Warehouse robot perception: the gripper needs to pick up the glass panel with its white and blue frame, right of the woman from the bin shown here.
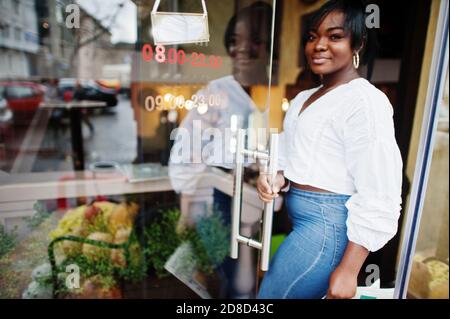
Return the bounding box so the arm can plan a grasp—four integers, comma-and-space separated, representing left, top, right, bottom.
396, 1, 449, 299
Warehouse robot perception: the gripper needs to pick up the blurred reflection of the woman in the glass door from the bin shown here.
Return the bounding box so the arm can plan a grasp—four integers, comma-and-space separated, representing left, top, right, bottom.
169, 2, 272, 297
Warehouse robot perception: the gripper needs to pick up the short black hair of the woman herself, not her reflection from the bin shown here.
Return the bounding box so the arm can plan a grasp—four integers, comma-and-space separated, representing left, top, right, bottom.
303, 0, 378, 78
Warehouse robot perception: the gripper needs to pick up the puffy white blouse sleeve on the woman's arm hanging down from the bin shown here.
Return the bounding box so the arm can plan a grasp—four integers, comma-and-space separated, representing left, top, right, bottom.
343, 98, 403, 251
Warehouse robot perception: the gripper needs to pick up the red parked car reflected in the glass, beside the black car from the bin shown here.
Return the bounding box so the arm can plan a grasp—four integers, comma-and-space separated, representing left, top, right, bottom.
0, 81, 45, 112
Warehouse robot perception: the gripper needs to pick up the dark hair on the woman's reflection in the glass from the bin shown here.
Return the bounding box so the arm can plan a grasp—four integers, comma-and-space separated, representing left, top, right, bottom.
224, 1, 273, 53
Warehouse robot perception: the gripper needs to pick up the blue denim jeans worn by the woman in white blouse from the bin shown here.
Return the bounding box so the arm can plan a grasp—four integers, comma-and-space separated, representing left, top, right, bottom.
258, 187, 350, 299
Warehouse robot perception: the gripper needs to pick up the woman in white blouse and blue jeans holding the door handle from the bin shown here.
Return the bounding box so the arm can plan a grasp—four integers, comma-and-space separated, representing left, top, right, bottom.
257, 0, 402, 298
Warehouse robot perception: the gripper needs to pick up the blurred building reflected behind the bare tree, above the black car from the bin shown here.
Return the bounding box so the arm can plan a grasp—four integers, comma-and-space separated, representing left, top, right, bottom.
36, 0, 131, 79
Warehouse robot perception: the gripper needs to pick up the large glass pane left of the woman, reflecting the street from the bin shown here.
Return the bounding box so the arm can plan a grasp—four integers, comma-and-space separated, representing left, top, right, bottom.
0, 0, 276, 298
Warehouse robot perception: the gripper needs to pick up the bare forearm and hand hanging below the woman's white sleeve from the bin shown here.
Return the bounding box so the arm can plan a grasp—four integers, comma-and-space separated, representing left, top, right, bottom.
327, 241, 369, 299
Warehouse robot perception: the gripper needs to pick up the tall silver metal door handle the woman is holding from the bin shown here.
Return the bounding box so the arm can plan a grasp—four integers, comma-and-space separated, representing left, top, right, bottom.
230, 129, 278, 271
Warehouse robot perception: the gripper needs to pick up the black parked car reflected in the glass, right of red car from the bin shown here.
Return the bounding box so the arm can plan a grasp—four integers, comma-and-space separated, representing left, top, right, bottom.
58, 79, 117, 106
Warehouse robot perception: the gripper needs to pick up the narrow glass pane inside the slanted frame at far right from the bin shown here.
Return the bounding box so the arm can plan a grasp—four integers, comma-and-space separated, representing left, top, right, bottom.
408, 70, 449, 299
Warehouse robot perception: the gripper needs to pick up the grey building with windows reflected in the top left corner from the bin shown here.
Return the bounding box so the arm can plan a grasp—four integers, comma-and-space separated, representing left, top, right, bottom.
0, 0, 39, 77
